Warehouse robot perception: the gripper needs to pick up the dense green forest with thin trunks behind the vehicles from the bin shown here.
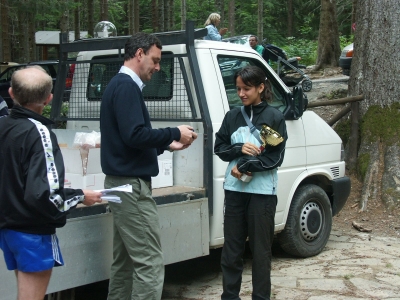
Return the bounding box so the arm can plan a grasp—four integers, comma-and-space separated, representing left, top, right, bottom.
0, 0, 355, 65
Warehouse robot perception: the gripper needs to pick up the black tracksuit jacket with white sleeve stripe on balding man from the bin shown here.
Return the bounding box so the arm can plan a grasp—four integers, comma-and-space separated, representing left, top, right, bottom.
0, 106, 84, 234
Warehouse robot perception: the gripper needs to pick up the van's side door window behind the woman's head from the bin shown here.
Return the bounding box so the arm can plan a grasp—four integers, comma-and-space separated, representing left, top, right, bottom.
217, 55, 287, 112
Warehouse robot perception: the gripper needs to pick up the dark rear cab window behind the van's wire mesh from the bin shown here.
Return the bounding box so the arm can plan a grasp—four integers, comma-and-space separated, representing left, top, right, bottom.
87, 55, 173, 101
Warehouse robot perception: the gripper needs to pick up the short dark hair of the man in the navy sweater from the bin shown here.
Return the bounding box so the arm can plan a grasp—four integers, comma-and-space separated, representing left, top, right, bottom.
124, 32, 162, 61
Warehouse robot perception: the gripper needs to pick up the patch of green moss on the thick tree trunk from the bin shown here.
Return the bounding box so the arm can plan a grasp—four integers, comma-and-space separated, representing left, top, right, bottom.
361, 103, 400, 145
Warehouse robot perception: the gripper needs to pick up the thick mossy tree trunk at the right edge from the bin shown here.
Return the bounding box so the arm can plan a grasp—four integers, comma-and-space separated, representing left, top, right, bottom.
349, 0, 400, 210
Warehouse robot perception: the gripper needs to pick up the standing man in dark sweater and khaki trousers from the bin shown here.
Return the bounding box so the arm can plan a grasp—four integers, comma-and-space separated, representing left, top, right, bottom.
100, 33, 197, 300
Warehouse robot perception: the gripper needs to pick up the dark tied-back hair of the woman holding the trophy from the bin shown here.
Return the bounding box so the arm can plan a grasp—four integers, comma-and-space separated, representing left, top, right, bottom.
233, 66, 272, 102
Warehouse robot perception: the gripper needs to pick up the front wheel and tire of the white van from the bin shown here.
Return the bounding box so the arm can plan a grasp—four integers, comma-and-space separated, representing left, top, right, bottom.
278, 184, 332, 257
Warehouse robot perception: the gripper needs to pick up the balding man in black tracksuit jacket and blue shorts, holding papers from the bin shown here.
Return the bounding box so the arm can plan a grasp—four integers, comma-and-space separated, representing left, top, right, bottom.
0, 66, 101, 300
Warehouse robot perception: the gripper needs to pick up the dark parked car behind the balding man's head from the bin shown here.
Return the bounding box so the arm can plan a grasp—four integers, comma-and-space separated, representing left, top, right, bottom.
0, 60, 73, 108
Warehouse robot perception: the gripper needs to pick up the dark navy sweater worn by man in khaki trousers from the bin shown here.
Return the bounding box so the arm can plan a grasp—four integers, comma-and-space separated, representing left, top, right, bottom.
100, 73, 181, 181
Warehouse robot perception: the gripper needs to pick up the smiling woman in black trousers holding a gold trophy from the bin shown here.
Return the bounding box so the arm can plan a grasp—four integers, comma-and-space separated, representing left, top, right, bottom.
214, 66, 287, 299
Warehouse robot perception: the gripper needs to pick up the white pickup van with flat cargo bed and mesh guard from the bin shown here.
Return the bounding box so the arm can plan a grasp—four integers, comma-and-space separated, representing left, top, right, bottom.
0, 22, 350, 298
